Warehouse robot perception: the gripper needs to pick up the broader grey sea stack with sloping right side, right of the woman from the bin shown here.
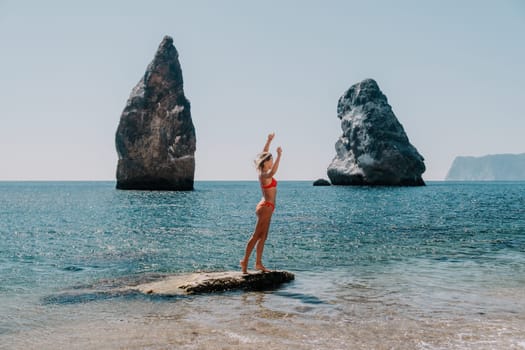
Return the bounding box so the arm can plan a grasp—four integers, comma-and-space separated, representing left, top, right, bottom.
328, 79, 425, 186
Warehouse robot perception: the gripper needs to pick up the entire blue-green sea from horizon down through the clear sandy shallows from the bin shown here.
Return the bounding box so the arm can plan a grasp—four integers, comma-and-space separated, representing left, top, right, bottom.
0, 181, 525, 349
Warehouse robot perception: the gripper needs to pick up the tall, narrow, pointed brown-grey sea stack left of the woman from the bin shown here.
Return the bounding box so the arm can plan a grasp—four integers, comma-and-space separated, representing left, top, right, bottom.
115, 36, 196, 190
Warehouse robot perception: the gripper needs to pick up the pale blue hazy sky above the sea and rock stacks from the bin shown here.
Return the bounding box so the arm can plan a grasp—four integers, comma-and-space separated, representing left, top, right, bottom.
0, 0, 525, 180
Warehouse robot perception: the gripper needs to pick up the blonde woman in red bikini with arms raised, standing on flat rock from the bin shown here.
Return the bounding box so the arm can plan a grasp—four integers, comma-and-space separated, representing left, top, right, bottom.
239, 133, 282, 274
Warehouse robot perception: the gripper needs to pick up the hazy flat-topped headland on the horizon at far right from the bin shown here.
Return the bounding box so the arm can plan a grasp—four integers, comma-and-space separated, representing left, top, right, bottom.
445, 153, 525, 181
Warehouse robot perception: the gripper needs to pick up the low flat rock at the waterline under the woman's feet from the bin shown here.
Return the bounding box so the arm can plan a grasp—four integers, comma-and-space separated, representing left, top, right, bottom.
133, 271, 295, 295
